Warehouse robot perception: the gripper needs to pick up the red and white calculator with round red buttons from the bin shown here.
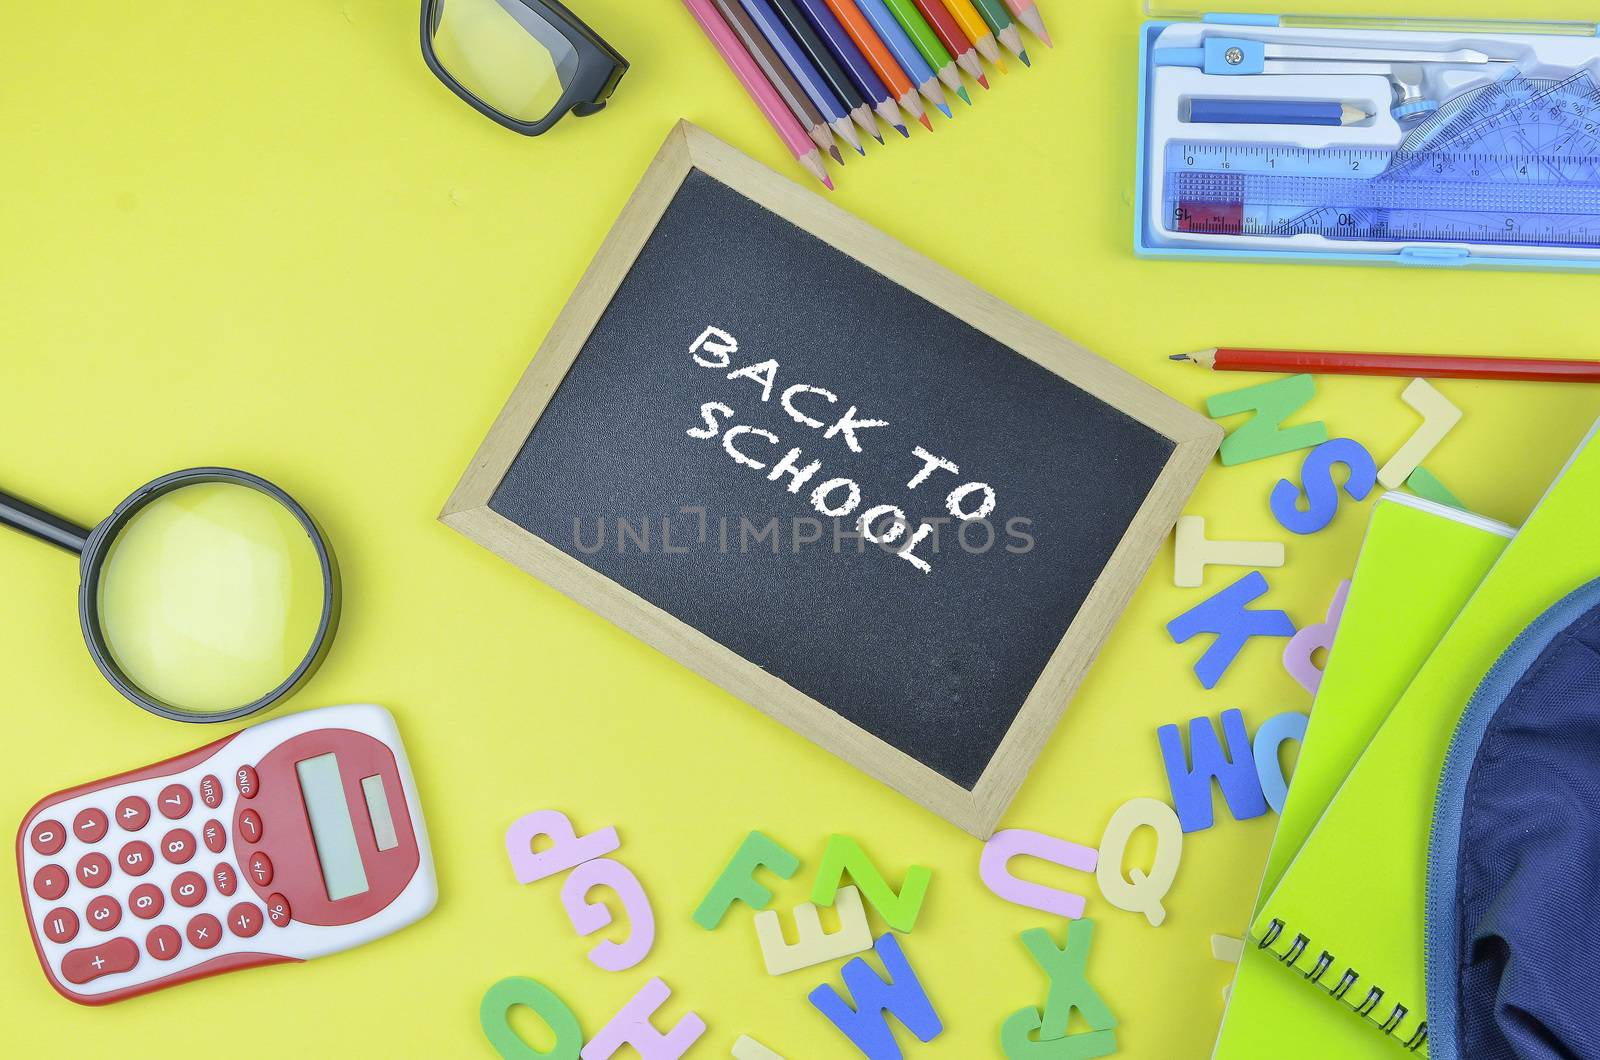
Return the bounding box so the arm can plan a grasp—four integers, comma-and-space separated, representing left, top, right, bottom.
16, 705, 438, 1004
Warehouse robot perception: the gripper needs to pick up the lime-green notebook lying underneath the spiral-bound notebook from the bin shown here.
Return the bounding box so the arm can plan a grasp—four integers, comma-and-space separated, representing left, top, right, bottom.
1213, 493, 1514, 1060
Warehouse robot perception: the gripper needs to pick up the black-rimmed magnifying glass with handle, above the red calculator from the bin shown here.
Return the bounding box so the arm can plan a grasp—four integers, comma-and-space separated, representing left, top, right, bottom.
0, 468, 339, 722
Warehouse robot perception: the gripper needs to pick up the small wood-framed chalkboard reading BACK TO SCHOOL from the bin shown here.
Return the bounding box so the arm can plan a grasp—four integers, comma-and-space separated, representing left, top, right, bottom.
442, 123, 1221, 836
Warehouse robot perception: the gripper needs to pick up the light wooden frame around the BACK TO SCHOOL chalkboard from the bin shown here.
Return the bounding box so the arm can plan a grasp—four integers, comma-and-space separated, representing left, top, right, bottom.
440, 122, 1222, 839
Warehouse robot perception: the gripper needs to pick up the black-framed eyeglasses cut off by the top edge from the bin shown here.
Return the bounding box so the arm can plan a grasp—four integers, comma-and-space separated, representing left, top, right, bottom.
422, 0, 627, 136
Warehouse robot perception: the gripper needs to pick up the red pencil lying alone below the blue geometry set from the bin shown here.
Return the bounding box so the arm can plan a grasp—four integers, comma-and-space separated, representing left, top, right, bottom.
1171, 347, 1600, 383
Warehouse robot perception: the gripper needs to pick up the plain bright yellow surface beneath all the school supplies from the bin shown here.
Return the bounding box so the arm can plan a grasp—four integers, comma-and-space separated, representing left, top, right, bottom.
0, 0, 1600, 1060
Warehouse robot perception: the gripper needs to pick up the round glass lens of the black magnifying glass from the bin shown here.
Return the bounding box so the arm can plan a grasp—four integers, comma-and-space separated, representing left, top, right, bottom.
98, 482, 325, 713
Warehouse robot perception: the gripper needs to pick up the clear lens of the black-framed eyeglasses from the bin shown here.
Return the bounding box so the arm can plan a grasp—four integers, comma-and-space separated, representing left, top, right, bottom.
434, 0, 578, 123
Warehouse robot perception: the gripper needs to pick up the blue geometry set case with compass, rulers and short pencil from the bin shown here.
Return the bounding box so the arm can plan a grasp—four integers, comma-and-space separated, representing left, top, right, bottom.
1134, 6, 1600, 271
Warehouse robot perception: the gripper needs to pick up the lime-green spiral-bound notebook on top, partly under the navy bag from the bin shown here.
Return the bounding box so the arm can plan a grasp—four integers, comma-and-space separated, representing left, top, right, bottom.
1251, 429, 1600, 1054
